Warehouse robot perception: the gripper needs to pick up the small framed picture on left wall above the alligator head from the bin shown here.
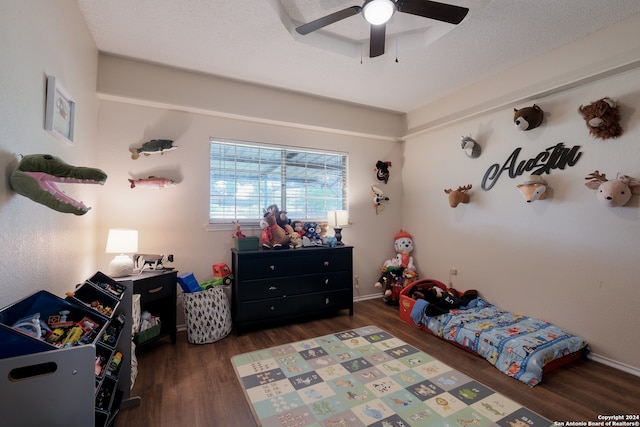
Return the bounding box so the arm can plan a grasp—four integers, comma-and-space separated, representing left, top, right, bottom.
44, 76, 76, 143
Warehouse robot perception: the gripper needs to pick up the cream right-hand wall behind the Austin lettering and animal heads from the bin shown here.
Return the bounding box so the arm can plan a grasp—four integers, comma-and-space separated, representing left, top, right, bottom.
403, 69, 640, 368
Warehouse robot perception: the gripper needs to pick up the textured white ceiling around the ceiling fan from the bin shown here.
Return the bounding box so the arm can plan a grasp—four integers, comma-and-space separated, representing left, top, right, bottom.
76, 0, 640, 112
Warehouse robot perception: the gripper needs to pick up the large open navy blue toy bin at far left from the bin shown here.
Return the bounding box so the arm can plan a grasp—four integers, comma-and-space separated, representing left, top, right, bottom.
0, 290, 107, 359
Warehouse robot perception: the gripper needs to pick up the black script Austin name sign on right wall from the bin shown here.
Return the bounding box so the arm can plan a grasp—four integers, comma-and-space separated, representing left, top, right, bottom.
482, 142, 582, 191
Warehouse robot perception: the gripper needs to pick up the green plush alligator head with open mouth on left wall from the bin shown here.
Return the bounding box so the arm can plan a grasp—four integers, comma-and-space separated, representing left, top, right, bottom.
10, 154, 107, 215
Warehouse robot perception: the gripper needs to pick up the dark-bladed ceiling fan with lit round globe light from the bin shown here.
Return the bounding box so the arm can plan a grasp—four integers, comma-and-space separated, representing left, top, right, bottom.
296, 0, 469, 58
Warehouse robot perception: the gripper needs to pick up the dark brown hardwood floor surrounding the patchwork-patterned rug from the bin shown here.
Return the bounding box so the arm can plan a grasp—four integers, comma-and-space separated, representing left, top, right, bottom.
117, 299, 640, 427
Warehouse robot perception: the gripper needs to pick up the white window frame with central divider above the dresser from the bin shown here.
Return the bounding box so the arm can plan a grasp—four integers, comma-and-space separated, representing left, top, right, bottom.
207, 137, 349, 229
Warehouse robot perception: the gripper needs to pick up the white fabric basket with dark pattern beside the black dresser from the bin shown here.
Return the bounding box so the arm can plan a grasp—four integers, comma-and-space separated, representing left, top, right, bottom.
182, 286, 232, 344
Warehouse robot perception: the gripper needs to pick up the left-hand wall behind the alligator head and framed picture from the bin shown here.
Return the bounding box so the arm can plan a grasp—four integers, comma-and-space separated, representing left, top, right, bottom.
0, 0, 100, 307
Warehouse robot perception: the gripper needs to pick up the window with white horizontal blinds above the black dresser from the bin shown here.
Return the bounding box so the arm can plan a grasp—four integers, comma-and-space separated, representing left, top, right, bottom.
209, 138, 348, 223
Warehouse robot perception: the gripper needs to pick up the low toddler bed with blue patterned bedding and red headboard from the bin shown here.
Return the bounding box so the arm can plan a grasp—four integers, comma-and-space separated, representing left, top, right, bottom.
399, 279, 587, 387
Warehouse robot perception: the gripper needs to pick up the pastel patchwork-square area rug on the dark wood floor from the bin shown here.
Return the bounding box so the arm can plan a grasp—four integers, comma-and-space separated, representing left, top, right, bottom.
231, 326, 552, 427
